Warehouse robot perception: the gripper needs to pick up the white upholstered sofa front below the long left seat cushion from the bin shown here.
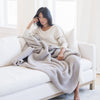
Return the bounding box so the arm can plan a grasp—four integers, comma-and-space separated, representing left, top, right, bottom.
0, 82, 60, 100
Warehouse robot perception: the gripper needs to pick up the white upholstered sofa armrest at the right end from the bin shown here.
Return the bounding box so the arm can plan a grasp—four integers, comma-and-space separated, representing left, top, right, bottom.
78, 42, 96, 71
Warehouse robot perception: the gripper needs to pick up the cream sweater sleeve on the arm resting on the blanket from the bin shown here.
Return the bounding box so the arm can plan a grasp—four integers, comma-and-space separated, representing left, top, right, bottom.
55, 27, 68, 48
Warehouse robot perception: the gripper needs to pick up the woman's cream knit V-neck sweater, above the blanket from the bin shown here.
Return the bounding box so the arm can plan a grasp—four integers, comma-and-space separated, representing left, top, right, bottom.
24, 25, 68, 48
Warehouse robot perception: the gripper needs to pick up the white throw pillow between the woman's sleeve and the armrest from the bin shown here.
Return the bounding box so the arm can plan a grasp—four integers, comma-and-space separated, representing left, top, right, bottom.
64, 29, 79, 52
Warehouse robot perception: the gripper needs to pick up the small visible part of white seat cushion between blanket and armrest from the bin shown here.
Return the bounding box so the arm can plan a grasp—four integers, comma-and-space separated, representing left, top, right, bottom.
80, 58, 92, 71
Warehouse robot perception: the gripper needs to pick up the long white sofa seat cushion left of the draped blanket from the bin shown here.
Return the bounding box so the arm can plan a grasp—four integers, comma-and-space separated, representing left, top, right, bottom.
0, 66, 50, 96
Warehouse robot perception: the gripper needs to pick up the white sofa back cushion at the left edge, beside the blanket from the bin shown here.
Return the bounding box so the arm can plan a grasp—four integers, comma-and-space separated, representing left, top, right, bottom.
0, 36, 21, 66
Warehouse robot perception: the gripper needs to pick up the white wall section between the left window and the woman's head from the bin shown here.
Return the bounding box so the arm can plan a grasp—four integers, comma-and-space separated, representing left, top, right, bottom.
17, 0, 35, 34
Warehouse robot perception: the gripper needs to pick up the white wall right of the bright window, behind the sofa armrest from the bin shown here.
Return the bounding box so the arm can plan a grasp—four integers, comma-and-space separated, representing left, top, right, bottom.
77, 0, 100, 72
